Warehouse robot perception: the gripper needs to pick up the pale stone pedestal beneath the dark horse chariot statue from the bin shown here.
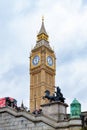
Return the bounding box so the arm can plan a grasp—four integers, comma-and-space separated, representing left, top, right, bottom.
41, 101, 68, 121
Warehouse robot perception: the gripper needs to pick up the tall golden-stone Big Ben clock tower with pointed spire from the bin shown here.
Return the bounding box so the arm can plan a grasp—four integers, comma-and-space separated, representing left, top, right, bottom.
30, 18, 56, 112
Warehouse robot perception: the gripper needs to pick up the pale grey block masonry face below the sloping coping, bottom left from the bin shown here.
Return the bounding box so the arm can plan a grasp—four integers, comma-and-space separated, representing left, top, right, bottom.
0, 109, 54, 130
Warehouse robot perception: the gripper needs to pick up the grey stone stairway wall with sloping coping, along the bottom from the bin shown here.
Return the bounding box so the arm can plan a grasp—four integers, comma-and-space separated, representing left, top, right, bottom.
0, 107, 81, 130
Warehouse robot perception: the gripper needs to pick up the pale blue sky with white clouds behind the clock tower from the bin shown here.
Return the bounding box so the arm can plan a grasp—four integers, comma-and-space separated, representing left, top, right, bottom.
0, 0, 87, 111
